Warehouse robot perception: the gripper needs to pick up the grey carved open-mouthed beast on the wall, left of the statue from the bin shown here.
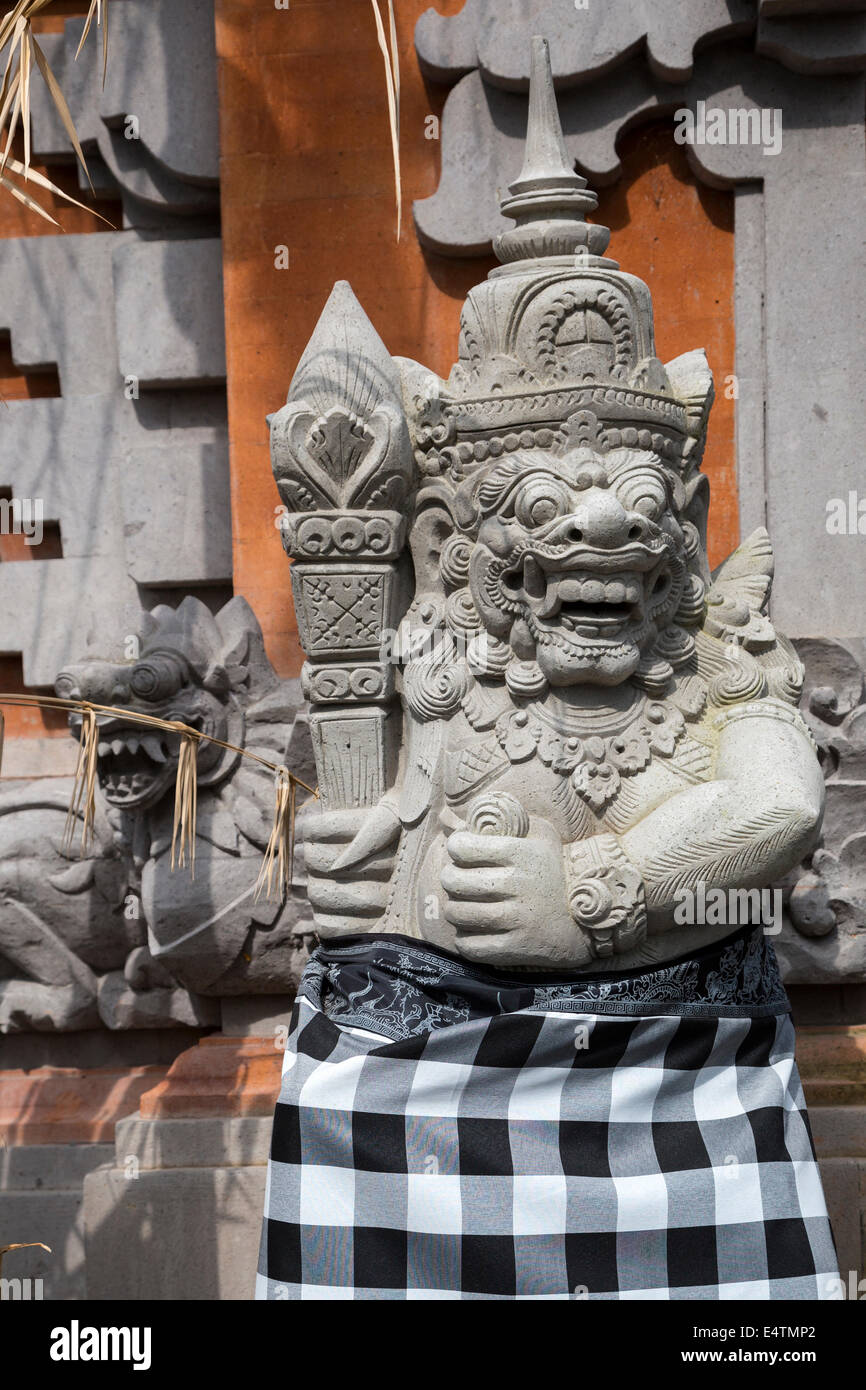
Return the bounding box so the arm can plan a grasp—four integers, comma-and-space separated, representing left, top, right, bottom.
0, 598, 313, 1031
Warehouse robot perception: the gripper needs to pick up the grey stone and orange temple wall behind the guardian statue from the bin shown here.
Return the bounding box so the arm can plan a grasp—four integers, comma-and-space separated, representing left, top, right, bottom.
0, 0, 866, 1298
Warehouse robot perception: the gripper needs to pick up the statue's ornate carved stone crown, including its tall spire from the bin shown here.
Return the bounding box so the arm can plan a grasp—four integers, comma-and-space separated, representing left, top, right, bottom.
407, 38, 712, 477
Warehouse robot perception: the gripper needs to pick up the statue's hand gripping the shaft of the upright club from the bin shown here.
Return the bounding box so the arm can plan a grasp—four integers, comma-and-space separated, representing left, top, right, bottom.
296, 806, 399, 938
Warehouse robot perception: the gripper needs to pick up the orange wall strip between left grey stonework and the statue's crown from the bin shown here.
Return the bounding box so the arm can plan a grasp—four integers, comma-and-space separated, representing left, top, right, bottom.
217, 0, 484, 674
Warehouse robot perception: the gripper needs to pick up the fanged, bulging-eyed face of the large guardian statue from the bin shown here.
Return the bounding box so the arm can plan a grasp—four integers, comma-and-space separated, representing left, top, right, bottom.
468, 449, 685, 687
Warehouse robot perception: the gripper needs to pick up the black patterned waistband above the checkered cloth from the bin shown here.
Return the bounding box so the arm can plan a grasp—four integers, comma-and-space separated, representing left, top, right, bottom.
299, 926, 791, 1040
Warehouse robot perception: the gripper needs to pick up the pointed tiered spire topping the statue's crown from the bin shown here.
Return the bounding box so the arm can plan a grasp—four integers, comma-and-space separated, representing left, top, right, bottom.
493, 35, 610, 261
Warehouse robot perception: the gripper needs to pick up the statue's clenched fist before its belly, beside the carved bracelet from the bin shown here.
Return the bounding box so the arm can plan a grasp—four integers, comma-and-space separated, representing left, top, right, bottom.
442, 819, 592, 969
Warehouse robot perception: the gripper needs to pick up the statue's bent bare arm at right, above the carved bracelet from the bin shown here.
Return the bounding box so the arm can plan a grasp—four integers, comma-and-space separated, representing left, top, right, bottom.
620, 706, 824, 931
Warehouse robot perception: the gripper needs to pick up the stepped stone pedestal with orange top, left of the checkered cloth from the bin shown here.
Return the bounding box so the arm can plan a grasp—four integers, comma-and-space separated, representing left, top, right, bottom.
85, 1034, 282, 1300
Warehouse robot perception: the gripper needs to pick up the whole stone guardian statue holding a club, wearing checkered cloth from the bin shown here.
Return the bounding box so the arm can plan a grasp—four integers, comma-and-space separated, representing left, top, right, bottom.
260, 39, 835, 1298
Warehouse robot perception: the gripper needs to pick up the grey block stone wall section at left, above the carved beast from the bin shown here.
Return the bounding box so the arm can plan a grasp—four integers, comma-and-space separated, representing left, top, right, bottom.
0, 0, 232, 761
